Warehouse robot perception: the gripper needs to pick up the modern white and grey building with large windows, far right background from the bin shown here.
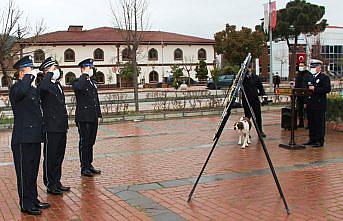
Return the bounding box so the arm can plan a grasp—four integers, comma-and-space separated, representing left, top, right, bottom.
258, 26, 343, 79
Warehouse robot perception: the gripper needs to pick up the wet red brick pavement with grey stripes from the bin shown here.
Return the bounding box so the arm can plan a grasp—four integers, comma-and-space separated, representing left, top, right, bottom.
0, 111, 343, 221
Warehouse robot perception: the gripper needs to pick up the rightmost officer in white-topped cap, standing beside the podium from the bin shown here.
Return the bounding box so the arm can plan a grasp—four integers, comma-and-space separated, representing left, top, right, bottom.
305, 64, 331, 147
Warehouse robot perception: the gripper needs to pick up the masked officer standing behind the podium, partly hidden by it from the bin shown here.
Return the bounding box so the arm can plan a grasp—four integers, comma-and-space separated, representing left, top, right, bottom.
295, 62, 312, 128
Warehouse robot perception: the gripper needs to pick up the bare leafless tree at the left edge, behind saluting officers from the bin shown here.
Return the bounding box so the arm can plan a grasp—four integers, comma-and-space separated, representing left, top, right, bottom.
0, 0, 45, 87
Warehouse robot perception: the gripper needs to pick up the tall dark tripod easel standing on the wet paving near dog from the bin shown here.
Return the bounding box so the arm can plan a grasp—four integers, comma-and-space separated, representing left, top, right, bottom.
188, 53, 290, 214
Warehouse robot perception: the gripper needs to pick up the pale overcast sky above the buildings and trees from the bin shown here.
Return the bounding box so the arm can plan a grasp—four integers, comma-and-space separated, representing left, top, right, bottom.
0, 0, 343, 38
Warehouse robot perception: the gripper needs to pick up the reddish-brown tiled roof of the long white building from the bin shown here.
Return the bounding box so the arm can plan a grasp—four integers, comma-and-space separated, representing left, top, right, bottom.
28, 27, 214, 45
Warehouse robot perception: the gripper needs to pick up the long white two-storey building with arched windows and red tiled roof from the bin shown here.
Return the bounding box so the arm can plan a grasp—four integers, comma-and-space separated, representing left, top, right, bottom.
0, 26, 215, 87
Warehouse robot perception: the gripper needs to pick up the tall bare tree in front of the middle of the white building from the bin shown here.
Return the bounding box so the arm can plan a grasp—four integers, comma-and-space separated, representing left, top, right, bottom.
111, 0, 148, 111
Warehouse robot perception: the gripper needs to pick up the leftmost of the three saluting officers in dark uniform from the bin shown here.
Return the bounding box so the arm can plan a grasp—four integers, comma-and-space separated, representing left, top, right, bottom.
9, 56, 50, 215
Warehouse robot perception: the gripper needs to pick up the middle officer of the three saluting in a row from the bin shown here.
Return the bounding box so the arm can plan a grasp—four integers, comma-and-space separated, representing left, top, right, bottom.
39, 57, 70, 195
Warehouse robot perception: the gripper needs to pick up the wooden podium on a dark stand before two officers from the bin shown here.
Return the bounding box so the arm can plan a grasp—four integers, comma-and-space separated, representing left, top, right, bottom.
275, 88, 312, 150
